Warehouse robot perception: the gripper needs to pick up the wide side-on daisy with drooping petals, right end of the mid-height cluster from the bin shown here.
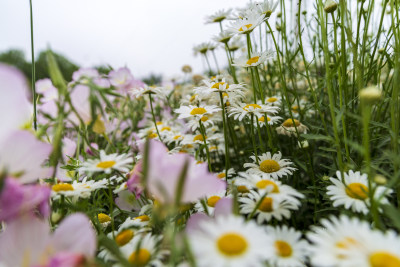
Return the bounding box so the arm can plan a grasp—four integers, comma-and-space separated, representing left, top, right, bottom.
228, 103, 278, 121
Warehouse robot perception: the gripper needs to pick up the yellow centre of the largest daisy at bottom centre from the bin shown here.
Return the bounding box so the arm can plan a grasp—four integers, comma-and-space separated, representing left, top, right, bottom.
217, 233, 248, 257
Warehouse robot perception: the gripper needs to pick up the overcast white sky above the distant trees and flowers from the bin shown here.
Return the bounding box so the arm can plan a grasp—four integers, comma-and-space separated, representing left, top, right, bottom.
0, 0, 247, 77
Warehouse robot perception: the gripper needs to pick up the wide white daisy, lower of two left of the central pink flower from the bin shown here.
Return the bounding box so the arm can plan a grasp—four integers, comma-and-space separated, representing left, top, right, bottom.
51, 177, 108, 202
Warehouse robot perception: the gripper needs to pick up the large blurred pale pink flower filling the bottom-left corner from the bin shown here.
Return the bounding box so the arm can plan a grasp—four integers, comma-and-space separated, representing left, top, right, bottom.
0, 213, 96, 267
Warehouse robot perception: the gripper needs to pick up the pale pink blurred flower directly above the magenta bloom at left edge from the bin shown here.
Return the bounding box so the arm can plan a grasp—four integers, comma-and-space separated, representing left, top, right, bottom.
0, 131, 52, 183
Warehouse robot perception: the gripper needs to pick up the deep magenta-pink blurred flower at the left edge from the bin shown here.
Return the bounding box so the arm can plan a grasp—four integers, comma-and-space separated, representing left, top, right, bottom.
0, 178, 51, 221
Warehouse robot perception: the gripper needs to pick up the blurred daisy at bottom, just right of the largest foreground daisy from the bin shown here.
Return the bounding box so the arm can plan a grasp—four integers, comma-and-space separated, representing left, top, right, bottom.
266, 225, 309, 267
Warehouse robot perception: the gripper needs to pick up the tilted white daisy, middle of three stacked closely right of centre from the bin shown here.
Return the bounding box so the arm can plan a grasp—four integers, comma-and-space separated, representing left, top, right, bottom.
235, 172, 304, 206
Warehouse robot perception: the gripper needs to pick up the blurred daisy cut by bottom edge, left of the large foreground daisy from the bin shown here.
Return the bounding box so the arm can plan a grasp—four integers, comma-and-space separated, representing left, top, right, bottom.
120, 234, 166, 266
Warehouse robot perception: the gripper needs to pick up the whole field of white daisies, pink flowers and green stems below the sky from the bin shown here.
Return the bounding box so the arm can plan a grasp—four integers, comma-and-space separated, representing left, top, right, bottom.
0, 0, 400, 267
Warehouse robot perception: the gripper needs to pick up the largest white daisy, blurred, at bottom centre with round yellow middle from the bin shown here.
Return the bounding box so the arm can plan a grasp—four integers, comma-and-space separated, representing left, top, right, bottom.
188, 215, 271, 267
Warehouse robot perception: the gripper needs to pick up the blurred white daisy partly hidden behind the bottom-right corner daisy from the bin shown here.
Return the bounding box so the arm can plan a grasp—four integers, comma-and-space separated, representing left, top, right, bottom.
307, 215, 379, 267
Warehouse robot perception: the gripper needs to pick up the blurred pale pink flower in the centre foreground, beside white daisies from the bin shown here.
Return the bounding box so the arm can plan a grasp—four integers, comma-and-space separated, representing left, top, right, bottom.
142, 140, 226, 202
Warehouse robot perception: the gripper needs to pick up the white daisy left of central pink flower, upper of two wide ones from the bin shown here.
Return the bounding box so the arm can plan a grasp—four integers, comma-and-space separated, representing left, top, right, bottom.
79, 150, 133, 174
